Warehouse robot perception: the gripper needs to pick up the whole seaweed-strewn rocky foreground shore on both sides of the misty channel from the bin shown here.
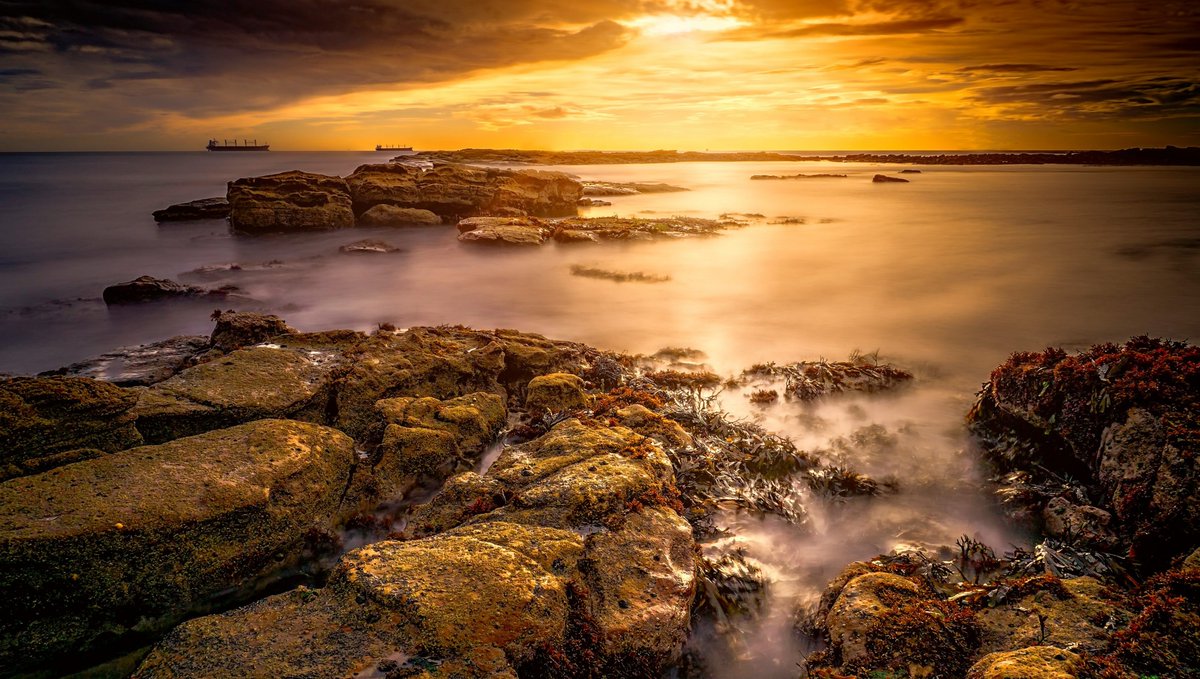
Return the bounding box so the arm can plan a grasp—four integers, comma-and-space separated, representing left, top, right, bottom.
0, 312, 1200, 678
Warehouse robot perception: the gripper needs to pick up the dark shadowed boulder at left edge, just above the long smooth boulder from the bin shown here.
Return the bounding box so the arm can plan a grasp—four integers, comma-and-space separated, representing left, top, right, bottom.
0, 377, 142, 479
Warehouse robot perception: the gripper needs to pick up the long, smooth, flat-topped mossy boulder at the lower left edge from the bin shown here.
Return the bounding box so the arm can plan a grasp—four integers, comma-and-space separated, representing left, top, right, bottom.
0, 420, 355, 671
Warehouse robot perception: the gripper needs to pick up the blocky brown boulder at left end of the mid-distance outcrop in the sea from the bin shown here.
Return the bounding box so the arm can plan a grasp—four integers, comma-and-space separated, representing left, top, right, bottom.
227, 170, 354, 234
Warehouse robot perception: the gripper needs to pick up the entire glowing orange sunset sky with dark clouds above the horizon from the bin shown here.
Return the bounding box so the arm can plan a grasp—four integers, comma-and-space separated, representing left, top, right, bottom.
0, 0, 1200, 151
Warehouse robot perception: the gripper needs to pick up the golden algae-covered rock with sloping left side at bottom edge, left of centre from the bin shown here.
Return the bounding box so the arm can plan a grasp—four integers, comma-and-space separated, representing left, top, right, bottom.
136, 522, 583, 679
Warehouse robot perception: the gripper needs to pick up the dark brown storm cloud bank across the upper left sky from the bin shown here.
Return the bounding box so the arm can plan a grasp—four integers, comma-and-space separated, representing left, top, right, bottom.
0, 0, 642, 122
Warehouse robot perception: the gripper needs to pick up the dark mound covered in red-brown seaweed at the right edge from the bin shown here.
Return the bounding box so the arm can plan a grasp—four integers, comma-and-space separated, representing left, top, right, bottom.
968, 337, 1200, 571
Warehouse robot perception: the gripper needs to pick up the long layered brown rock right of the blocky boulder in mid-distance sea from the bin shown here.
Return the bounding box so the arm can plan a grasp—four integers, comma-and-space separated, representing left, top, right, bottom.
346, 163, 583, 220
